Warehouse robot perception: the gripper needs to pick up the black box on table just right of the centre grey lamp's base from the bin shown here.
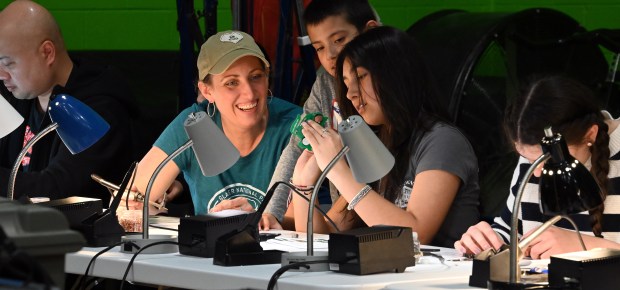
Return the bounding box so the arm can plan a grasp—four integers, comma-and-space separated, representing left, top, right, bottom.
328, 226, 415, 275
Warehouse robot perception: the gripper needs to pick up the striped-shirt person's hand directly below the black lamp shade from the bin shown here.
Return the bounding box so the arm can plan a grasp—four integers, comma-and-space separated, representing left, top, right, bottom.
523, 227, 583, 259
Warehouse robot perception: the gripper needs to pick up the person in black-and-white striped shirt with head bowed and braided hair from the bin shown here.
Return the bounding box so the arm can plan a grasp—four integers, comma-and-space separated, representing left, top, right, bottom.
454, 76, 620, 259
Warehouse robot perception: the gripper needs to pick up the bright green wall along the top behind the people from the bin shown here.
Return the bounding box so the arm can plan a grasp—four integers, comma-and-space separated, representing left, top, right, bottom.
0, 0, 620, 50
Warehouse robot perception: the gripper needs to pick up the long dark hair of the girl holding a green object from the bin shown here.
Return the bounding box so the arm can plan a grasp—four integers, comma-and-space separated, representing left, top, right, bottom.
336, 26, 448, 201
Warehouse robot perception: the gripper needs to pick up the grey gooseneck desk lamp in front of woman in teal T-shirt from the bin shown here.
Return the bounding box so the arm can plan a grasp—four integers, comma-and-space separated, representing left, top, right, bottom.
121, 112, 240, 254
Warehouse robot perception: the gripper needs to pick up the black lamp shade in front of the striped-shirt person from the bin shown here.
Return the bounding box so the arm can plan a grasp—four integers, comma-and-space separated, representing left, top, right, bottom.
540, 134, 603, 215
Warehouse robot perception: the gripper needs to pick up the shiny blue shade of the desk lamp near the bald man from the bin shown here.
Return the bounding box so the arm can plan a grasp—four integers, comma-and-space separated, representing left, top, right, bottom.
48, 94, 110, 154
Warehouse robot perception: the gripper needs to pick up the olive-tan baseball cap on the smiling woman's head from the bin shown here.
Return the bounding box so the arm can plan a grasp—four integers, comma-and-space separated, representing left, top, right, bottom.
197, 30, 269, 80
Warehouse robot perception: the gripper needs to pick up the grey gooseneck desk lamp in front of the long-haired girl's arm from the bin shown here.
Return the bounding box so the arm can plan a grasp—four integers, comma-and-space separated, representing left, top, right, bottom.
282, 115, 394, 271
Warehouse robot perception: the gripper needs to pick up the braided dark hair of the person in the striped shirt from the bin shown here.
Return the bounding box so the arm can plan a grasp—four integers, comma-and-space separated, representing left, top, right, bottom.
504, 76, 610, 237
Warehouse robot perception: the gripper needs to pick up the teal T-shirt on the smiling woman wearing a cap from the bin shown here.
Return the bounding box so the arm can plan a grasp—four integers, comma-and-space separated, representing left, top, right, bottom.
154, 98, 301, 214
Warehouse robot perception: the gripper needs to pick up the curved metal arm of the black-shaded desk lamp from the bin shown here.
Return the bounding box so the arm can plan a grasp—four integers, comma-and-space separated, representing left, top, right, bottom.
509, 153, 551, 283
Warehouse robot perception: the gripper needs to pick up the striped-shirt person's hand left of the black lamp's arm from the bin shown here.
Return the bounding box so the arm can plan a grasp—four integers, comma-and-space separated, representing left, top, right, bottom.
454, 222, 504, 254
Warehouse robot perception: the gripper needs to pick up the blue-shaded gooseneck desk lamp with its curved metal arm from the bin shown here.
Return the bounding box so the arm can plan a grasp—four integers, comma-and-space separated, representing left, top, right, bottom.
6, 94, 110, 200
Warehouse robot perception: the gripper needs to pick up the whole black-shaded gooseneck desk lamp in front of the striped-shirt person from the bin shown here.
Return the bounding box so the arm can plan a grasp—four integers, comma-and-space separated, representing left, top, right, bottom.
488, 127, 603, 289
